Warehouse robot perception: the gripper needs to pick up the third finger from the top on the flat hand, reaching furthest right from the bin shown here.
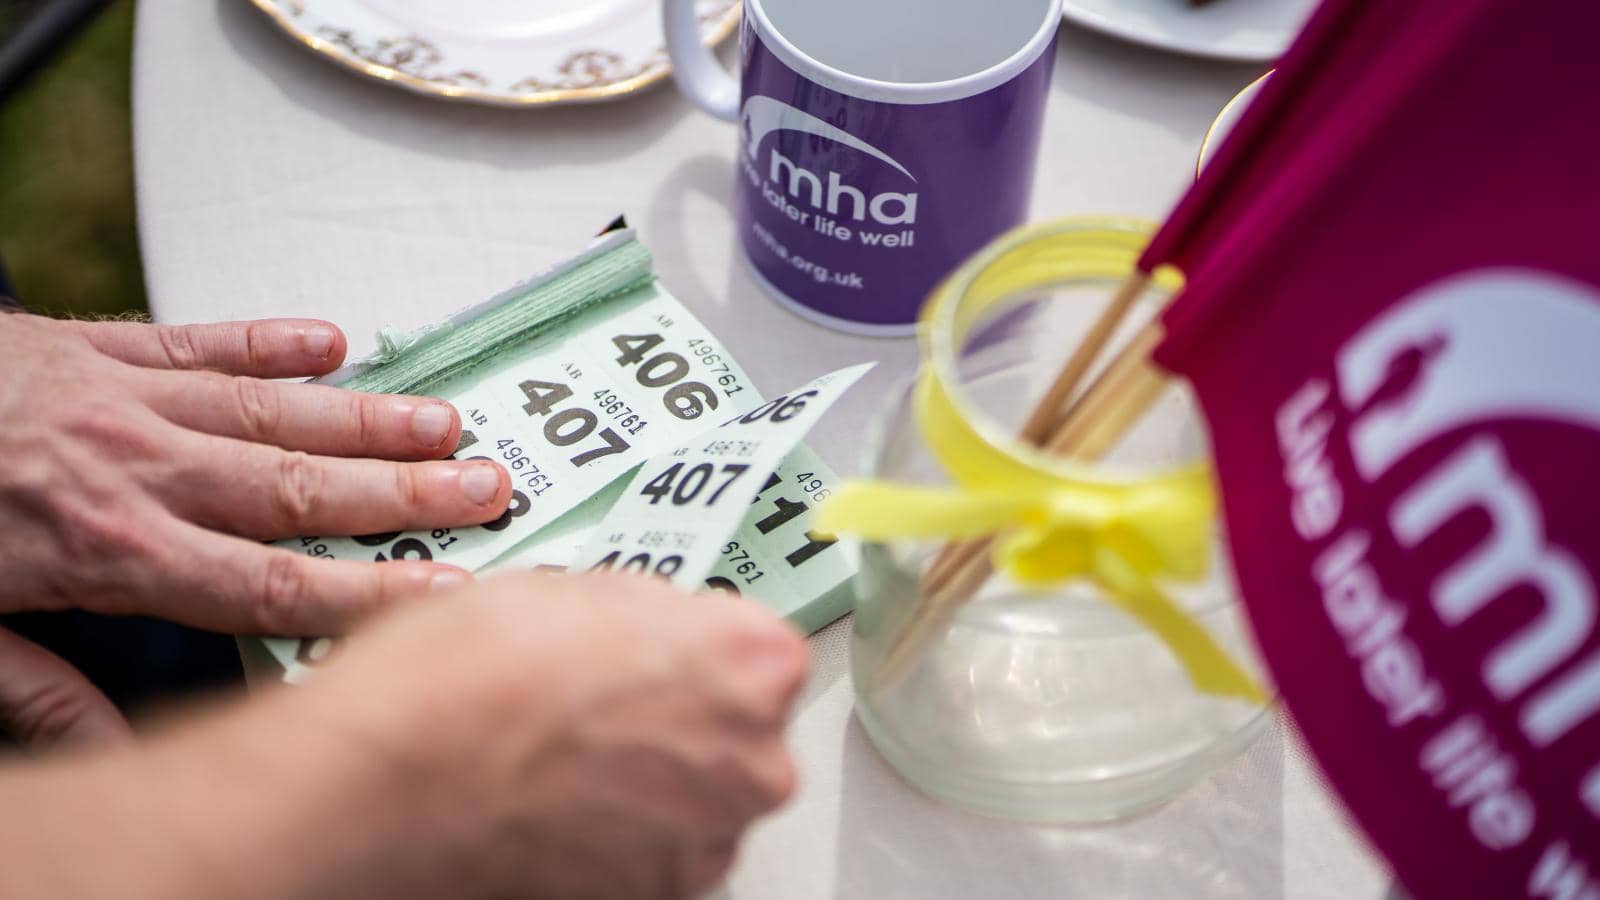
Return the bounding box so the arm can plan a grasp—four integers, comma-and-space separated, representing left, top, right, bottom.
150, 432, 510, 540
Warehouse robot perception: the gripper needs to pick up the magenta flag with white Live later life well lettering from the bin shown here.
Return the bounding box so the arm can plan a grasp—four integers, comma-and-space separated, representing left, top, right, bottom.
1155, 0, 1600, 900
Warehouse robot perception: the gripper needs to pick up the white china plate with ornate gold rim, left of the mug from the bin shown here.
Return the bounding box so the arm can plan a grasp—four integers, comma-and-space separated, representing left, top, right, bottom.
251, 0, 739, 106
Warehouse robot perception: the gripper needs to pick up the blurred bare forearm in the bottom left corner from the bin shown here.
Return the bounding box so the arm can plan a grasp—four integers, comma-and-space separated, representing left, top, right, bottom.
0, 679, 438, 900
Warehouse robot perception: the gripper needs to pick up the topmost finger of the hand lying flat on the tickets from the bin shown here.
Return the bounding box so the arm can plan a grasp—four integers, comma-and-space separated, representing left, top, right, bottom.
62, 319, 346, 378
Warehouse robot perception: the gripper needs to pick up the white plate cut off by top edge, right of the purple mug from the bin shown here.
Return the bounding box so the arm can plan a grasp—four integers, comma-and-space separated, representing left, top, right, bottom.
1062, 0, 1317, 62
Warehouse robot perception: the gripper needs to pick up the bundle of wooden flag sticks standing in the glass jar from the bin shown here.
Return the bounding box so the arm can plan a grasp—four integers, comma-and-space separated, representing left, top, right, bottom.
875, 271, 1168, 690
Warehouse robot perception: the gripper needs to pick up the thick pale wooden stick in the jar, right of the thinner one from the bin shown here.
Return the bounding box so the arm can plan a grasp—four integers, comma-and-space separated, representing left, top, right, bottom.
874, 322, 1168, 692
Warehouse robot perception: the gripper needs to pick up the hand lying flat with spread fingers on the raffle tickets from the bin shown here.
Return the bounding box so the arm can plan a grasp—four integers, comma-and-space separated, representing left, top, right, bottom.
0, 314, 510, 741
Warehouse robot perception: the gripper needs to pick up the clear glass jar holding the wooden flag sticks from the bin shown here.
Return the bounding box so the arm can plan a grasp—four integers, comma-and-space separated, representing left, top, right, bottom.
851, 221, 1269, 823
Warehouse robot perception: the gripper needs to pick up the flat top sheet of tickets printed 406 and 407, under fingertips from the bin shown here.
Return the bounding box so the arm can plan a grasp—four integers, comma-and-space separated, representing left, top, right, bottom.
280, 287, 758, 572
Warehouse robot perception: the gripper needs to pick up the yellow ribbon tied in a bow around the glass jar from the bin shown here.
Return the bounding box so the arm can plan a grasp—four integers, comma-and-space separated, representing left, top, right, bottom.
816, 221, 1266, 703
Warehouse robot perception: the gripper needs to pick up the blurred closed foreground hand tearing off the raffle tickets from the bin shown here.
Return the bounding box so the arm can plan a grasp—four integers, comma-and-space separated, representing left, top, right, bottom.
256, 575, 808, 900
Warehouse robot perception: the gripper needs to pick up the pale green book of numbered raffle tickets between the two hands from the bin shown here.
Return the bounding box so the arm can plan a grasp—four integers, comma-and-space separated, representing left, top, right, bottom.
242, 229, 870, 682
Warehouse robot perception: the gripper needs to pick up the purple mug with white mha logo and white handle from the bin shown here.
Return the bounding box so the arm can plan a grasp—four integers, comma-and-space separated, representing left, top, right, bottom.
664, 0, 1061, 336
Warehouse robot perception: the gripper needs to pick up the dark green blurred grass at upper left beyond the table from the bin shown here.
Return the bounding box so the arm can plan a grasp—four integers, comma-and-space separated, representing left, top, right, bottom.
0, 0, 146, 315
